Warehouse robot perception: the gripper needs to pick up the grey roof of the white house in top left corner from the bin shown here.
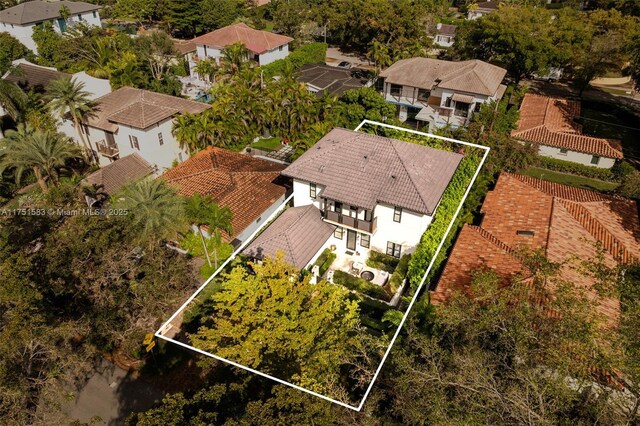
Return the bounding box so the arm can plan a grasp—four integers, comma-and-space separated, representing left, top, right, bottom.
0, 0, 101, 25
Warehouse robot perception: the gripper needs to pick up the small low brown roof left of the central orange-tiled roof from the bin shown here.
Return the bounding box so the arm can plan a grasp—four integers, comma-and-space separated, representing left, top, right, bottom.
83, 153, 154, 194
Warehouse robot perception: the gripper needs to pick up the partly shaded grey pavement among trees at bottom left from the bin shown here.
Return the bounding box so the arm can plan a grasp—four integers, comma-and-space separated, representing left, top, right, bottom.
62, 360, 163, 426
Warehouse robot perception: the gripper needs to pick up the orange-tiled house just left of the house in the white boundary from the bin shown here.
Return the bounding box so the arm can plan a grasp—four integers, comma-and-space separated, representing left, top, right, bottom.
161, 147, 289, 246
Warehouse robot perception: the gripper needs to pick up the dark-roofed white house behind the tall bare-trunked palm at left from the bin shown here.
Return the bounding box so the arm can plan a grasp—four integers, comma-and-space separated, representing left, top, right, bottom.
2, 59, 111, 99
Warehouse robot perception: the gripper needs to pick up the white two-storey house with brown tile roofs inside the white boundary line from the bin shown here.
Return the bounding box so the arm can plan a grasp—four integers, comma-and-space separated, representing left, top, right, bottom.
245, 129, 462, 267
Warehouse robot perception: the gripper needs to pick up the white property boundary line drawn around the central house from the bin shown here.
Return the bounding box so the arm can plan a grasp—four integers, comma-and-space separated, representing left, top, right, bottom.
155, 120, 490, 411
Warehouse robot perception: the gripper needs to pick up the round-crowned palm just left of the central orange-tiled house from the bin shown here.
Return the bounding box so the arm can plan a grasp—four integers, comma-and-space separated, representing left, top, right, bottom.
112, 179, 185, 246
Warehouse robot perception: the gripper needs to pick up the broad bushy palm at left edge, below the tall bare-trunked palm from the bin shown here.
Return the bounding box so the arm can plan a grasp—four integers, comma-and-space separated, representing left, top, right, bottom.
0, 124, 82, 192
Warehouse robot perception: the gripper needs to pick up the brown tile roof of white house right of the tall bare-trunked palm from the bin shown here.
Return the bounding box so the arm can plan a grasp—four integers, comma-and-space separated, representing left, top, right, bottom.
85, 87, 210, 132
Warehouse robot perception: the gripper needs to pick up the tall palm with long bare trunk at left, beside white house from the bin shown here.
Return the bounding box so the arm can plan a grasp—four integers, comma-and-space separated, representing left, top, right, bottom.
47, 77, 97, 162
